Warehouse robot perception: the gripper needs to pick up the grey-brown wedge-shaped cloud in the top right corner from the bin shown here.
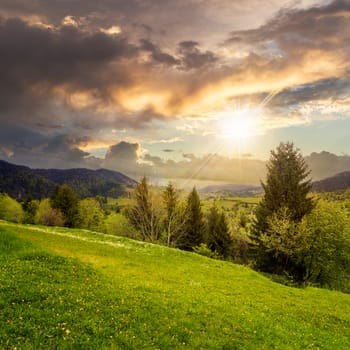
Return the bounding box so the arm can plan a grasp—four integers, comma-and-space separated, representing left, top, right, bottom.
227, 0, 350, 54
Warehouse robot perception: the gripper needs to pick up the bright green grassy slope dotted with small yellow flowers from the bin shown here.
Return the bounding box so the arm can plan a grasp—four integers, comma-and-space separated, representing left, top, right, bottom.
0, 222, 350, 349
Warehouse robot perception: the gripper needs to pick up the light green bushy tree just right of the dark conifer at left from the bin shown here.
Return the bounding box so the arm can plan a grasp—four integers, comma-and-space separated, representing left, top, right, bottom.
79, 198, 105, 232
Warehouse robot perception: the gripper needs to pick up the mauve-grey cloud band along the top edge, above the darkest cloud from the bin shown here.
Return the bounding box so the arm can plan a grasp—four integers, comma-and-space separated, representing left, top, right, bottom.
0, 0, 252, 36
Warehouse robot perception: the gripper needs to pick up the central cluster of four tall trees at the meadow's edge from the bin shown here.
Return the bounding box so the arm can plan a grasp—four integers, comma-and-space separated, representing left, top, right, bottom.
124, 177, 233, 258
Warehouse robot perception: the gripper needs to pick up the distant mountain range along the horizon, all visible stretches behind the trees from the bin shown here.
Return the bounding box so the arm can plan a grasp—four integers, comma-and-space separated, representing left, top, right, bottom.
0, 160, 350, 200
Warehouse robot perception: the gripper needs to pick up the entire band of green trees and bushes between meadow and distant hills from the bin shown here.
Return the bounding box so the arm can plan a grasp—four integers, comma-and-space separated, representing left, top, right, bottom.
0, 142, 350, 292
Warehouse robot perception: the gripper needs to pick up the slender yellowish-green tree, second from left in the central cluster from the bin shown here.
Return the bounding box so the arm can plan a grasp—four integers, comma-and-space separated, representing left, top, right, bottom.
163, 182, 185, 247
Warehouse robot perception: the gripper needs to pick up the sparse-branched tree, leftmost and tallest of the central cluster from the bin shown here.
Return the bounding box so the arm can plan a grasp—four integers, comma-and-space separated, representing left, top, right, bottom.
125, 177, 161, 242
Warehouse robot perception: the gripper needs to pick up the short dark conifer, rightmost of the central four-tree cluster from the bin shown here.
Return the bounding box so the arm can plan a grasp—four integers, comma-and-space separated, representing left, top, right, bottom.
207, 204, 232, 258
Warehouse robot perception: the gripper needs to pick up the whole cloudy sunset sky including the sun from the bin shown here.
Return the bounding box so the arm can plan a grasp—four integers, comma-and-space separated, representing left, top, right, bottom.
0, 0, 350, 185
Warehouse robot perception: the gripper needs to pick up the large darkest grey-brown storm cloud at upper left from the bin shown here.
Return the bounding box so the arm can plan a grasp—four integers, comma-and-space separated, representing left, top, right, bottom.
0, 19, 135, 114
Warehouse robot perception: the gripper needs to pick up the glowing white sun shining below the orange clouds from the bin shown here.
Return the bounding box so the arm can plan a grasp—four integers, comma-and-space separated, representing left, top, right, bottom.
218, 108, 257, 142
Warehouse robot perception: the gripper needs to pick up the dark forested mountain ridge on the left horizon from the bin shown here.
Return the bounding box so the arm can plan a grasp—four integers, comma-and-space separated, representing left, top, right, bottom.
0, 160, 137, 199
